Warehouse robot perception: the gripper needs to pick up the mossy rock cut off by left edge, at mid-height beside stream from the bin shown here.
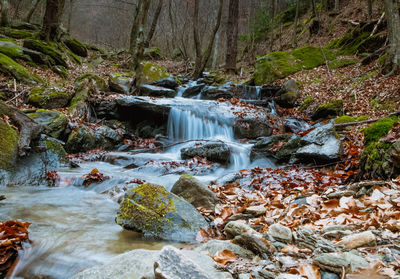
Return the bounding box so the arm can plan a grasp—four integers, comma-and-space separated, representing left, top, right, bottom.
0, 120, 18, 171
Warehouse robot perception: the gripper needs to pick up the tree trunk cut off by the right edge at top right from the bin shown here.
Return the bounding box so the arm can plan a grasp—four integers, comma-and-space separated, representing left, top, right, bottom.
382, 0, 400, 76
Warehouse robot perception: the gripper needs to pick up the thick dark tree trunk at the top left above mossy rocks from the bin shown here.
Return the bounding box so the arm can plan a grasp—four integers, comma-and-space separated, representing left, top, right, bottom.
40, 0, 65, 41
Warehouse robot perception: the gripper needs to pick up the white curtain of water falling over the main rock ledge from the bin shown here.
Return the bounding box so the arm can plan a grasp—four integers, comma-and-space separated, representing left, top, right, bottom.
168, 108, 234, 141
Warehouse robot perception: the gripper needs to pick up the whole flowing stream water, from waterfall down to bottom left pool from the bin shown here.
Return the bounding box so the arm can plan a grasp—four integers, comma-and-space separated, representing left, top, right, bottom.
0, 83, 273, 278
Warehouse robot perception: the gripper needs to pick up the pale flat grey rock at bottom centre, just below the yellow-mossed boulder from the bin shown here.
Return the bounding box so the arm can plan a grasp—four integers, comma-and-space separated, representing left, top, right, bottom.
194, 240, 254, 259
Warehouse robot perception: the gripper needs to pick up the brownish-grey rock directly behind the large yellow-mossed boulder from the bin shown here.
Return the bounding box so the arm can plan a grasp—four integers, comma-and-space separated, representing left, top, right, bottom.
171, 175, 219, 210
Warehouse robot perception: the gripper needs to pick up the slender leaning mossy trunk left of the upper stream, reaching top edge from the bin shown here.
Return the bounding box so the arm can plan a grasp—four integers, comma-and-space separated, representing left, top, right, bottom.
130, 0, 151, 88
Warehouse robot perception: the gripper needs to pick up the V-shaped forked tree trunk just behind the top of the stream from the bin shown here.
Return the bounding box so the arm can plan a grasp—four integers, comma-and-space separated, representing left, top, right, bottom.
193, 0, 224, 79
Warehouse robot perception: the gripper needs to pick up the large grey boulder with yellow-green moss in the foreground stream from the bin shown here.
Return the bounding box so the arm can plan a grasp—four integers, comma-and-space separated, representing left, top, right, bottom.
116, 183, 207, 241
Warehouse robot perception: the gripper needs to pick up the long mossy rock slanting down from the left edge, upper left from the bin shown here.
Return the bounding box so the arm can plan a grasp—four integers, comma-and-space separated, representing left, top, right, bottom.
0, 53, 40, 83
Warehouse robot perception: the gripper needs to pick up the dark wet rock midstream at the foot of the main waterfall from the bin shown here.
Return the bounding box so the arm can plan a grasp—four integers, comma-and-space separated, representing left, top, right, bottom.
181, 142, 231, 165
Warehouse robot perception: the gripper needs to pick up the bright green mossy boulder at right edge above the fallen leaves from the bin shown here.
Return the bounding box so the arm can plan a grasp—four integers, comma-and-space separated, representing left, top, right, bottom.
360, 116, 400, 178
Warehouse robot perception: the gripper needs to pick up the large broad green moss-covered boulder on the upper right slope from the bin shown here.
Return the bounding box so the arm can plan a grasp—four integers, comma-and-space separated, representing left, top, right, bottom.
254, 46, 335, 85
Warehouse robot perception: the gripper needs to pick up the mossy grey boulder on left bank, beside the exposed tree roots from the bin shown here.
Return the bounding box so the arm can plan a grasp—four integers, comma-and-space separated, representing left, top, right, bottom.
28, 109, 68, 138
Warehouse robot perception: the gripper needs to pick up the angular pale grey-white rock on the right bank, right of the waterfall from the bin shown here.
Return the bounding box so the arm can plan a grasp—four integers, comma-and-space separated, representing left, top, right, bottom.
295, 124, 342, 164
